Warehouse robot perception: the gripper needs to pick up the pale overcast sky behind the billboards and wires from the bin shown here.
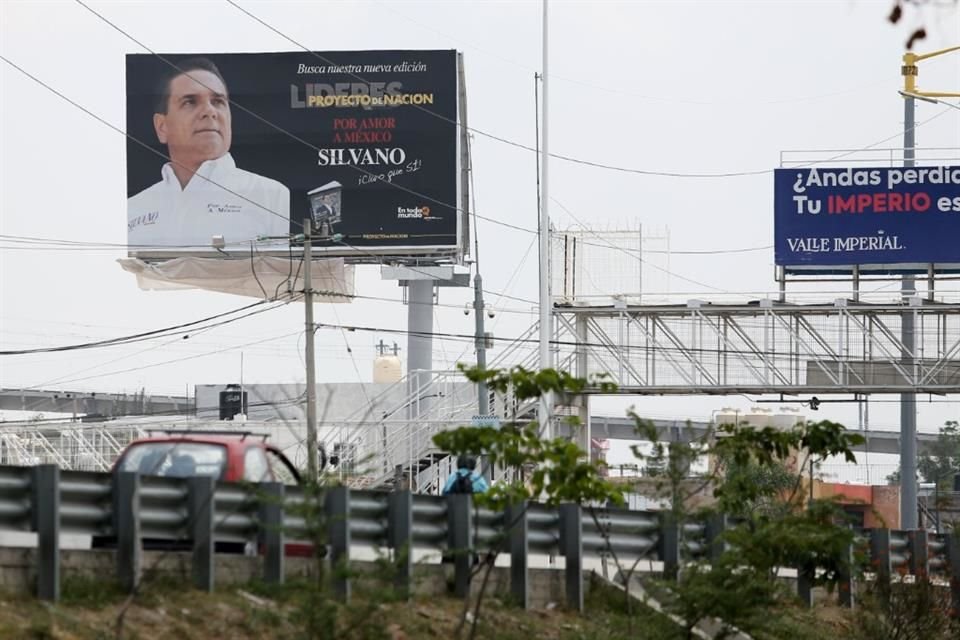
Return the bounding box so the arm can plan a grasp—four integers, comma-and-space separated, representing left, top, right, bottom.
0, 0, 960, 462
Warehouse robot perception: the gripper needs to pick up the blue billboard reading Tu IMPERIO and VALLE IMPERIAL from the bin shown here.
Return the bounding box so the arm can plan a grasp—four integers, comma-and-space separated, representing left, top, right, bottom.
774, 166, 960, 271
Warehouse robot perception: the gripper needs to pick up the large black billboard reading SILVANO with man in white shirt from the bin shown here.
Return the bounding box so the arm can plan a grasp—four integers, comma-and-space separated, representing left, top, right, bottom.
126, 51, 465, 258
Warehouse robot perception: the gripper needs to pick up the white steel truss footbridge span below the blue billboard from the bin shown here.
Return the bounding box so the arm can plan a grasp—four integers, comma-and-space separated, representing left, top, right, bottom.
554, 297, 960, 395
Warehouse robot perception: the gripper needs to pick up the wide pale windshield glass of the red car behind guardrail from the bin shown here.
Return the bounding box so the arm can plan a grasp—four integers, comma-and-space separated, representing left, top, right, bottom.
117, 442, 227, 478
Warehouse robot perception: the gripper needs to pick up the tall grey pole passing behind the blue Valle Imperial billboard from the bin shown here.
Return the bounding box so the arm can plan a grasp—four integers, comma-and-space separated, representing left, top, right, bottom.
900, 91, 917, 529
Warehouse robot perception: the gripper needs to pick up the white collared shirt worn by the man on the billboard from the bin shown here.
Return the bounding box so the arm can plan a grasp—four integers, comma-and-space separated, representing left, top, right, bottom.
127, 153, 290, 250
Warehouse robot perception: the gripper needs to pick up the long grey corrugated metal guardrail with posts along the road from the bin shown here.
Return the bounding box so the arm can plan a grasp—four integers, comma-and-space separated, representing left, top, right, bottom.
0, 465, 960, 610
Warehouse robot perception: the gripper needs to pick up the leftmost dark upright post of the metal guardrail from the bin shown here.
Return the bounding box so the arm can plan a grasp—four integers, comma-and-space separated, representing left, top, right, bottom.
31, 464, 60, 602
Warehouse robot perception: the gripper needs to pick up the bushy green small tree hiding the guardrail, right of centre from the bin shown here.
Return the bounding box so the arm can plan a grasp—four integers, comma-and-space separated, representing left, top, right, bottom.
640, 421, 863, 634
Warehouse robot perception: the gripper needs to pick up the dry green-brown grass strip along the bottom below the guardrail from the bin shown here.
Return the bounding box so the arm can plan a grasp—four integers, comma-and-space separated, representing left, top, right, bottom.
0, 579, 872, 640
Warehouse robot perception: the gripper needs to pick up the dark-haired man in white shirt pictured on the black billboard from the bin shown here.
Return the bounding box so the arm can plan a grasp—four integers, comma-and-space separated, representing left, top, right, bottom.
127, 58, 290, 250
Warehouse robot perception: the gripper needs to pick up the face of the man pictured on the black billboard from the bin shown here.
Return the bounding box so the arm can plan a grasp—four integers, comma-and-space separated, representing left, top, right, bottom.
153, 70, 232, 170
